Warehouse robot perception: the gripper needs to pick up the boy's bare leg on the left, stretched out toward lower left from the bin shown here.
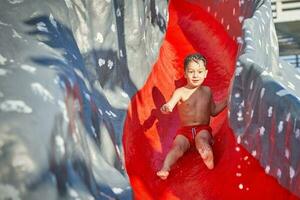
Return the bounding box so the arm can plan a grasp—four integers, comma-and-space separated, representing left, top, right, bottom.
156, 135, 190, 179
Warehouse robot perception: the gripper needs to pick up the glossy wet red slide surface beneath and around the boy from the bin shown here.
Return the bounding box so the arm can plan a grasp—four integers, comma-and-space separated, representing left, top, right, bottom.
123, 0, 297, 200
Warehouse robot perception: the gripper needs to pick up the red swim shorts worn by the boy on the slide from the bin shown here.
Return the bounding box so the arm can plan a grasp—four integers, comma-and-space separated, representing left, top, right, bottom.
176, 125, 212, 144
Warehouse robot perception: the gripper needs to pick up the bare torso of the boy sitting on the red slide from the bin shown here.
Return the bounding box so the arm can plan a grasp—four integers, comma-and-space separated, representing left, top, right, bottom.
177, 86, 211, 126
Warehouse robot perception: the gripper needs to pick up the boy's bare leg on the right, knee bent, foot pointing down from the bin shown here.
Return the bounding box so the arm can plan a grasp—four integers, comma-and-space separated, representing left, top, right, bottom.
195, 130, 214, 169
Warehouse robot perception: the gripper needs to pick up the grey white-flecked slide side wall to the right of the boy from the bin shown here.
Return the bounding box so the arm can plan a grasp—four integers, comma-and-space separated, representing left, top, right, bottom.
229, 1, 300, 196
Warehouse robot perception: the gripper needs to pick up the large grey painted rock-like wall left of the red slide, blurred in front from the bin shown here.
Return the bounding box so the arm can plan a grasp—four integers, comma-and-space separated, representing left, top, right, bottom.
0, 0, 168, 200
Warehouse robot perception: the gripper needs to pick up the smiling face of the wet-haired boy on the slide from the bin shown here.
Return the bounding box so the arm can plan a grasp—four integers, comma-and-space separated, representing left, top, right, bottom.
184, 60, 207, 87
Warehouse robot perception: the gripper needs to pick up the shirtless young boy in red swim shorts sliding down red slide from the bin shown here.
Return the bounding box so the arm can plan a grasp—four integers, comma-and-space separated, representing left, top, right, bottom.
157, 53, 227, 179
